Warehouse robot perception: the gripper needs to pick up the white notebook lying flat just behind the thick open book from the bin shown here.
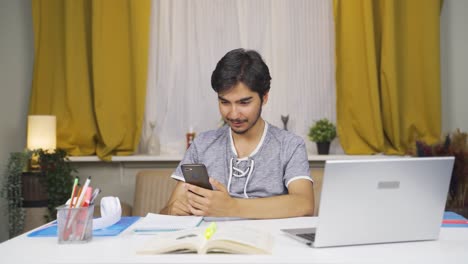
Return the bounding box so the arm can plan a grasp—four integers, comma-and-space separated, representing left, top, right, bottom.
133, 213, 203, 234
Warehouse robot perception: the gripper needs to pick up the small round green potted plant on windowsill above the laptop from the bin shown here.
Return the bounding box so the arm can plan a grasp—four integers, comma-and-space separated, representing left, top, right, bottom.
309, 118, 336, 154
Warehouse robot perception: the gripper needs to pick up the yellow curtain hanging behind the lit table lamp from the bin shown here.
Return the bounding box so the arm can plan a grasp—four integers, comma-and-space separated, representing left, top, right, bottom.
29, 0, 151, 160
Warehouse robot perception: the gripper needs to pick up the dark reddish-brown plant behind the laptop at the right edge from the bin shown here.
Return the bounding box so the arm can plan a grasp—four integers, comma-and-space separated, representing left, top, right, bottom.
409, 129, 468, 217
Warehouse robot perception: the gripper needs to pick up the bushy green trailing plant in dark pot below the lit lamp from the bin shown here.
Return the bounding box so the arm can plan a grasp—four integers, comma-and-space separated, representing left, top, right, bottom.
1, 149, 76, 237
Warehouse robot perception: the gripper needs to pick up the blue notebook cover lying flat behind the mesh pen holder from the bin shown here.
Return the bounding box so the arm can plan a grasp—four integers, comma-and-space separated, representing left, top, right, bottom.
27, 216, 140, 237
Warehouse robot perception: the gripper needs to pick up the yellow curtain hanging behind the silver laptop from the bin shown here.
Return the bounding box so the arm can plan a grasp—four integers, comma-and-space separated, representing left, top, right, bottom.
334, 0, 442, 154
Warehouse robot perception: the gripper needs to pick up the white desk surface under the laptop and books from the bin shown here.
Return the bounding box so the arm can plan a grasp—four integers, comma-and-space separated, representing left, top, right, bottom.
0, 217, 468, 264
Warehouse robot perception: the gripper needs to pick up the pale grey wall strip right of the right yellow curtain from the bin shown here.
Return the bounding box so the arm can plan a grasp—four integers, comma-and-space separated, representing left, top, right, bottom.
440, 0, 468, 132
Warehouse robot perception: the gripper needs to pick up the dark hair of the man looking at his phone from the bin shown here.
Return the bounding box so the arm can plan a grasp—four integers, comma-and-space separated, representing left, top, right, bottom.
211, 49, 271, 101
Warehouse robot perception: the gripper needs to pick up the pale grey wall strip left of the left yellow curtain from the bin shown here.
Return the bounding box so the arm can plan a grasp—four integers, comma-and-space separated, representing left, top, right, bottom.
0, 0, 34, 242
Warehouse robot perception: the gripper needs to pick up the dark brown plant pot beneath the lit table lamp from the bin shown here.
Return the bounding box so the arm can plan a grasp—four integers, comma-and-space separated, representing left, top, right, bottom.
21, 172, 49, 207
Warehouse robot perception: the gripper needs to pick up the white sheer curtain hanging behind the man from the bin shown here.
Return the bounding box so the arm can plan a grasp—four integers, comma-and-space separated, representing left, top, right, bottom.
141, 0, 336, 154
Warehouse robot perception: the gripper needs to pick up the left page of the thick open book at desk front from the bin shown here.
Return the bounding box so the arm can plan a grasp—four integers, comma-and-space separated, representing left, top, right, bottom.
136, 228, 205, 254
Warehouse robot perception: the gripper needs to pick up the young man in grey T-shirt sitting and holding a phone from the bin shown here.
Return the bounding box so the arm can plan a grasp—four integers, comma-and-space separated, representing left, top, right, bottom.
161, 49, 314, 218
